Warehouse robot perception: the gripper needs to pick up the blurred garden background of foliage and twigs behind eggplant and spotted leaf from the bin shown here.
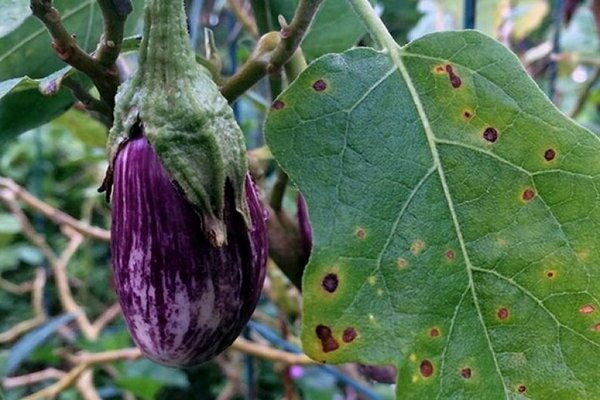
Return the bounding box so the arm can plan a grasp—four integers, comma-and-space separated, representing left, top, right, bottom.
0, 0, 600, 400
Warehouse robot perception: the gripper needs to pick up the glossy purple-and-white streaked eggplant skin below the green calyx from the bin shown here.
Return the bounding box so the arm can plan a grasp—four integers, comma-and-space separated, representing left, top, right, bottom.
111, 135, 268, 367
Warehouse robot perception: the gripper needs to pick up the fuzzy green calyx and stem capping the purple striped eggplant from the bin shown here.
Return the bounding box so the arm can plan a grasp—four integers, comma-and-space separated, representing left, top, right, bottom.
108, 0, 250, 246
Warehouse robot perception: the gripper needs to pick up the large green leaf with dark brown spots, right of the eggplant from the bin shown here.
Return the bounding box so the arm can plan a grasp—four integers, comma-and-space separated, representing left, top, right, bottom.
266, 29, 600, 399
